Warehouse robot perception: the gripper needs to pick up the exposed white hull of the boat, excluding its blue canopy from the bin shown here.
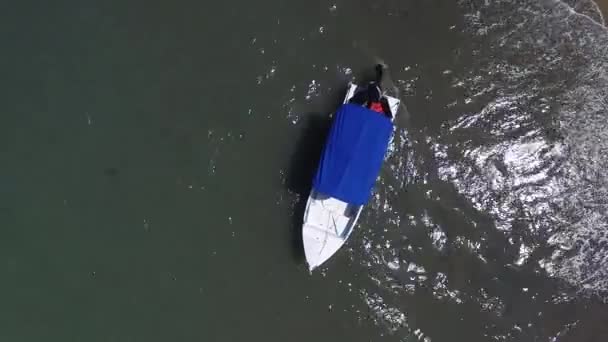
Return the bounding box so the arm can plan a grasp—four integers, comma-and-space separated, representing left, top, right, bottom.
302, 84, 400, 271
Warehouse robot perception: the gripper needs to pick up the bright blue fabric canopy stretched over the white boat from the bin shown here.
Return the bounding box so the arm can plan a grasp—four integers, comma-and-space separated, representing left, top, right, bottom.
313, 104, 393, 205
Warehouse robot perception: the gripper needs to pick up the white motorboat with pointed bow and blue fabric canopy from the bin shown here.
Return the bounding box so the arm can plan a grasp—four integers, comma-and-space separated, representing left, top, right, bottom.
302, 84, 400, 271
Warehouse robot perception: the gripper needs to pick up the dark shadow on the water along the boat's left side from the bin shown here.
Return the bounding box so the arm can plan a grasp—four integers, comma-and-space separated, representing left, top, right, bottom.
286, 113, 331, 263
